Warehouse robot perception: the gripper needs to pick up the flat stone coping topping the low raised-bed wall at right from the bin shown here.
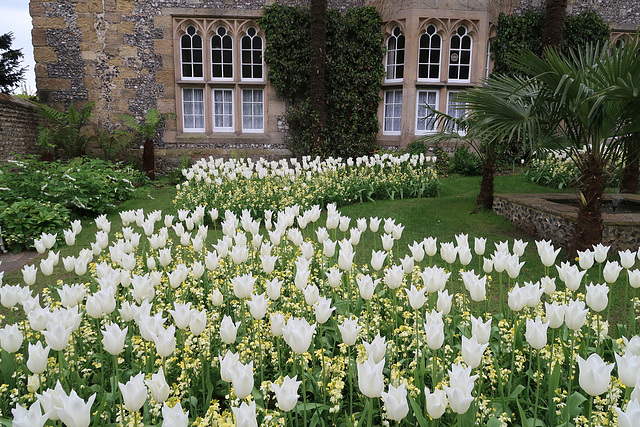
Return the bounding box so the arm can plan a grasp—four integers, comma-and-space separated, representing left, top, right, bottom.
494, 193, 640, 227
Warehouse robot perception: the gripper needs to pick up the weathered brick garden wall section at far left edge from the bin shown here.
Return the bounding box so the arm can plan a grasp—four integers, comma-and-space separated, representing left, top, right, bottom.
0, 93, 40, 161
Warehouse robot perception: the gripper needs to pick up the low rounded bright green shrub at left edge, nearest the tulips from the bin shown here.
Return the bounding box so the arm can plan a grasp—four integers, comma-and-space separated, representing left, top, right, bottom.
0, 199, 71, 252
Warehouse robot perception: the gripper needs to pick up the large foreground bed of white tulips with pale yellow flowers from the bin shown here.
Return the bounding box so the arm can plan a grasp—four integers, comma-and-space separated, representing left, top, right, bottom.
0, 205, 640, 426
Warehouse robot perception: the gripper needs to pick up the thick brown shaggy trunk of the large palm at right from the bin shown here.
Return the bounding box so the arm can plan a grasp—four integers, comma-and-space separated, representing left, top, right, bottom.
569, 155, 604, 256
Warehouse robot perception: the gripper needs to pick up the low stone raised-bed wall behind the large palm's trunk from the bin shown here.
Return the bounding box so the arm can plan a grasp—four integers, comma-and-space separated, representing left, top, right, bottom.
493, 194, 640, 252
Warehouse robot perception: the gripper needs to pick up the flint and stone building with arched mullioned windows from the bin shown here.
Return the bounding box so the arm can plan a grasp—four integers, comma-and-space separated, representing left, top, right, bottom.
30, 0, 640, 162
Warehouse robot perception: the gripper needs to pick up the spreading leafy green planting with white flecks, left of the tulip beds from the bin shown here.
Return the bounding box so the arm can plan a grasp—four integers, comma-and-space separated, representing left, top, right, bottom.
0, 156, 141, 251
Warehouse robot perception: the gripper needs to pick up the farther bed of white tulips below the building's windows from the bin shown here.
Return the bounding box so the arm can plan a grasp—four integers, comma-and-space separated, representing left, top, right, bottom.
174, 154, 439, 218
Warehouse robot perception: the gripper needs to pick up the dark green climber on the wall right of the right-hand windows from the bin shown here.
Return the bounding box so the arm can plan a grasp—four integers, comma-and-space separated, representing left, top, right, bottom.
491, 11, 611, 75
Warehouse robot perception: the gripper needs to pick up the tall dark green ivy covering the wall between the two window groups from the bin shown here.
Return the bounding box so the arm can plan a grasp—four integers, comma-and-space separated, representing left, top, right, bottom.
259, 4, 384, 157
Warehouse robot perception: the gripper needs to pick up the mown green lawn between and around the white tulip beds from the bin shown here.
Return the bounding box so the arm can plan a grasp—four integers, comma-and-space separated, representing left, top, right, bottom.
0, 174, 627, 331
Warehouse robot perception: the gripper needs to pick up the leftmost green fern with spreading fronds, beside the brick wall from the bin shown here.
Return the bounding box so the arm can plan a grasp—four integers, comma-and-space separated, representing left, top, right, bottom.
37, 102, 93, 158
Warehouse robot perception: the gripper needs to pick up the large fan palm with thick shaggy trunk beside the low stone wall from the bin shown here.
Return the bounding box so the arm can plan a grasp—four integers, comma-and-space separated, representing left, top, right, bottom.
517, 41, 640, 253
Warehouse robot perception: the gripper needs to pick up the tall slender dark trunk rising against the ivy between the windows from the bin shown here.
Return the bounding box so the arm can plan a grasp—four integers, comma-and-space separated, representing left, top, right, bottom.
309, 0, 327, 154
